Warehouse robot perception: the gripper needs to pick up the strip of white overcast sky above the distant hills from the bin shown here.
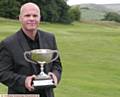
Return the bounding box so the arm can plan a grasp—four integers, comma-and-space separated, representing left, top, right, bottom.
67, 0, 120, 5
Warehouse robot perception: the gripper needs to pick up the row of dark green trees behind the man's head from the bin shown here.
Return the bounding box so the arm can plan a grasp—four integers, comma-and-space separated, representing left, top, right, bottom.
0, 0, 80, 23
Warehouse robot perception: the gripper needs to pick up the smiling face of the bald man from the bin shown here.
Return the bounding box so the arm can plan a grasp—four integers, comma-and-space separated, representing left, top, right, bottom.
19, 6, 40, 31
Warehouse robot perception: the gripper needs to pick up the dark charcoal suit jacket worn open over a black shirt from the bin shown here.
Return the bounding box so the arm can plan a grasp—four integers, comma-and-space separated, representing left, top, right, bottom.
0, 30, 62, 97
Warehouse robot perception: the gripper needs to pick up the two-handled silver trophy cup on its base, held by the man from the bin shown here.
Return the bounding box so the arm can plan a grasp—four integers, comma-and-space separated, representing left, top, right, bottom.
24, 49, 58, 87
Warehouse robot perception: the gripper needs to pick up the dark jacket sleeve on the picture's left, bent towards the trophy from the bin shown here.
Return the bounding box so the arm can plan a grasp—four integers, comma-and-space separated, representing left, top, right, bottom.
0, 42, 26, 87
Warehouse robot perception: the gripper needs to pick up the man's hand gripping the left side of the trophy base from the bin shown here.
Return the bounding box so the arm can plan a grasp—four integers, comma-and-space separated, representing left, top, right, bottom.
25, 75, 36, 91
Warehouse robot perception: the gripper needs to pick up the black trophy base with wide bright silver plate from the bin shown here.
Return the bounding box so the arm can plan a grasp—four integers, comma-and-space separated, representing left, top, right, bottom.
33, 79, 56, 88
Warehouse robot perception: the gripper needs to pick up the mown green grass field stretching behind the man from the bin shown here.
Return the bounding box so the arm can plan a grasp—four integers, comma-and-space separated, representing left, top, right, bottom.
0, 19, 120, 97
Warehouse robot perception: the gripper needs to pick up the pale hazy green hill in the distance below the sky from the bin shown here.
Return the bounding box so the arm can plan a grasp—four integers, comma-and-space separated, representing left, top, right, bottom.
77, 4, 120, 20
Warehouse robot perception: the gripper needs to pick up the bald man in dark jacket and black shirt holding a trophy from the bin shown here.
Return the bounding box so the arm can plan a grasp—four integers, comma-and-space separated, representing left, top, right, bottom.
0, 3, 62, 97
